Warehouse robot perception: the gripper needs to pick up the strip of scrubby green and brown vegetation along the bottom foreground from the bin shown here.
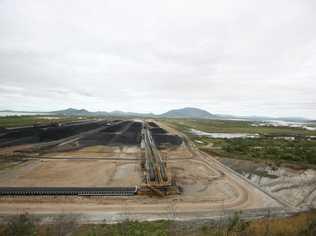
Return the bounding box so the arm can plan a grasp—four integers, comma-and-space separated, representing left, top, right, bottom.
0, 211, 316, 236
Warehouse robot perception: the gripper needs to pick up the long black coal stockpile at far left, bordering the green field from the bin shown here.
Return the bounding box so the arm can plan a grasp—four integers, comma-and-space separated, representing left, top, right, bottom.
0, 122, 104, 147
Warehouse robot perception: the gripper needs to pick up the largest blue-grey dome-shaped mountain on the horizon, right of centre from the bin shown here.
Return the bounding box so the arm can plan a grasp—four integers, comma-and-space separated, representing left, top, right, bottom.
160, 107, 216, 119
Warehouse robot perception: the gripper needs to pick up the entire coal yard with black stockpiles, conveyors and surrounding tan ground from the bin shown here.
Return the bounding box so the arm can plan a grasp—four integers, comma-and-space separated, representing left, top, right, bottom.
0, 119, 286, 218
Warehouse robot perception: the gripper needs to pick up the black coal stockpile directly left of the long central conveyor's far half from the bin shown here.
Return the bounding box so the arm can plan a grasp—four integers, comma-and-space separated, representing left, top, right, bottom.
79, 121, 143, 146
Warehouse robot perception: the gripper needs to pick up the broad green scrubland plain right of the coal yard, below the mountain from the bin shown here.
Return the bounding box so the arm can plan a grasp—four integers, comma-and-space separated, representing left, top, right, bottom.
164, 119, 316, 165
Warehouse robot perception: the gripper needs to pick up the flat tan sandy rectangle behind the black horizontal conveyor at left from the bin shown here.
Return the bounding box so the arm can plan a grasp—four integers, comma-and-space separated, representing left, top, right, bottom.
0, 160, 141, 187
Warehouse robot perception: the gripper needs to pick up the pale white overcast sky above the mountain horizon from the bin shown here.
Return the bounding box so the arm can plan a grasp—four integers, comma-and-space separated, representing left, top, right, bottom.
0, 0, 316, 118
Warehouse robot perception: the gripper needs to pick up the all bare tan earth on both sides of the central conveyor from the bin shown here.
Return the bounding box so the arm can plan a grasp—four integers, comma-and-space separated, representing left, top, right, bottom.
0, 121, 287, 221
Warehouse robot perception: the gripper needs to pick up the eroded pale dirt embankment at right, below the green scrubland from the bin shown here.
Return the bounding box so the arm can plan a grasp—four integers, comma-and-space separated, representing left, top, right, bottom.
218, 158, 316, 208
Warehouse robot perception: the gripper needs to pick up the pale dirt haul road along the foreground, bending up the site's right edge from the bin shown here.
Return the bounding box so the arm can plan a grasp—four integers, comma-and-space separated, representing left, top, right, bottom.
0, 123, 298, 223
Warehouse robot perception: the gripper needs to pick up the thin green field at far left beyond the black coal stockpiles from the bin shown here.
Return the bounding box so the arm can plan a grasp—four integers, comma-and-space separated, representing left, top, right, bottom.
0, 116, 87, 128
